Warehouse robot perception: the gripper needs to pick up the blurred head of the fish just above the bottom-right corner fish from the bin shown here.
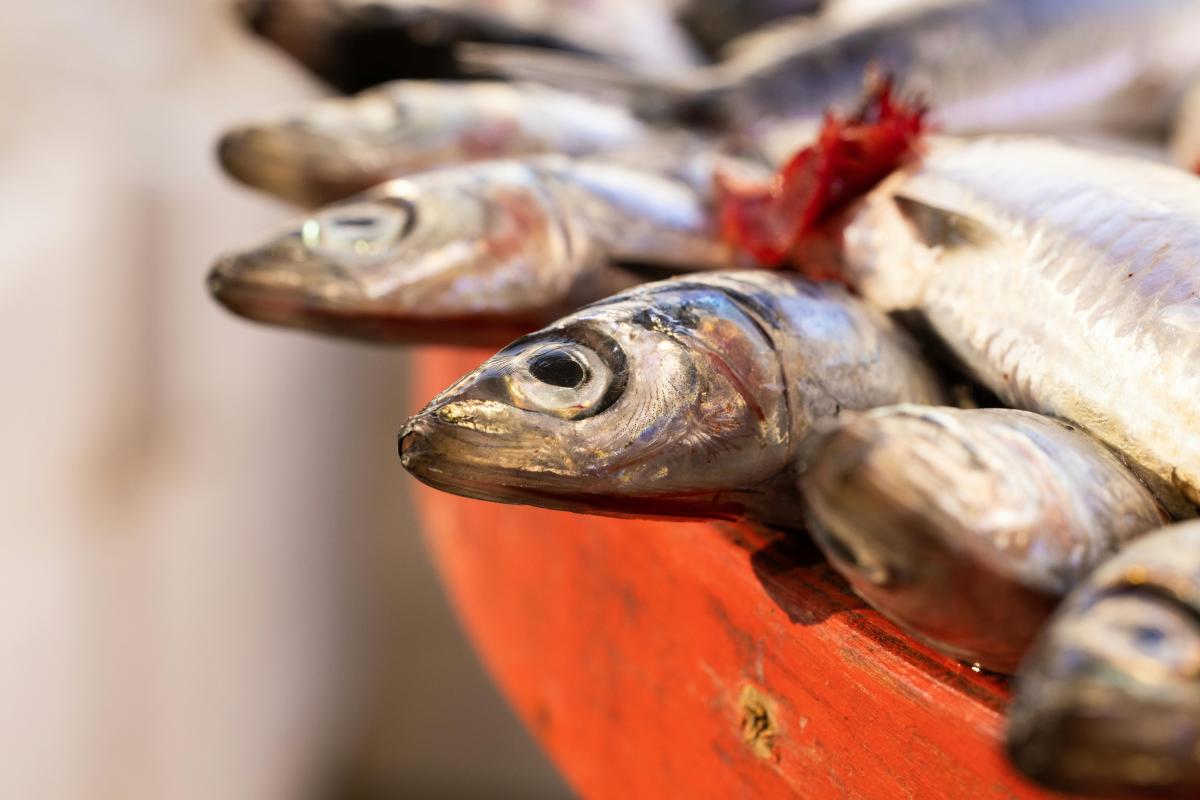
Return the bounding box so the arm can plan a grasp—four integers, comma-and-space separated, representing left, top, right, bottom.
800, 405, 1062, 672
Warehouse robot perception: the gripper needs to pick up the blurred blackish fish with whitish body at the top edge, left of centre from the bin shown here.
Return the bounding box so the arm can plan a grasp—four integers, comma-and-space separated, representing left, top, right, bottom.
238, 0, 697, 92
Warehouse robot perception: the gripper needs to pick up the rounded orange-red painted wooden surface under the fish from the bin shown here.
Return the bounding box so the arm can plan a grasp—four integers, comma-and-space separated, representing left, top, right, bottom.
414, 350, 1075, 800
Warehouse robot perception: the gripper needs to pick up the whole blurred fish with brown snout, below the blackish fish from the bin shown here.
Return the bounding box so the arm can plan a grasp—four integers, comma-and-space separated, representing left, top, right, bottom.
217, 80, 650, 207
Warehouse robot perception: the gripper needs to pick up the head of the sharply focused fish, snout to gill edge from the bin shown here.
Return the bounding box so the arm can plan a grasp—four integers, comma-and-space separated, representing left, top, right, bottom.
400, 281, 790, 518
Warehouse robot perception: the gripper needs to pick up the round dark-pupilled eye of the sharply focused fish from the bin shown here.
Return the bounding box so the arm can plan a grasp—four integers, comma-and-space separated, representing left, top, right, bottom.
505, 341, 625, 420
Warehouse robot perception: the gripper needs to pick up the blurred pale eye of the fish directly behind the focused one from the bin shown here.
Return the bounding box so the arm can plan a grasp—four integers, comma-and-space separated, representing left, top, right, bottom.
300, 201, 414, 266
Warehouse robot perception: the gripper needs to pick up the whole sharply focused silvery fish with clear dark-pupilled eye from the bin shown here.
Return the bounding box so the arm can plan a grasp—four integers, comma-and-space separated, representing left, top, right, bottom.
400, 270, 943, 528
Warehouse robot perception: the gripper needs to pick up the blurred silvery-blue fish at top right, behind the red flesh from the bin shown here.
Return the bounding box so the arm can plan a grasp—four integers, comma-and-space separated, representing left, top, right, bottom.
463, 0, 1200, 139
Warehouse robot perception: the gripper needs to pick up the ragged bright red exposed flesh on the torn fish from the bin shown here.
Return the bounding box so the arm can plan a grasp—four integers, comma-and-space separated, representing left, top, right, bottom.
716, 79, 925, 272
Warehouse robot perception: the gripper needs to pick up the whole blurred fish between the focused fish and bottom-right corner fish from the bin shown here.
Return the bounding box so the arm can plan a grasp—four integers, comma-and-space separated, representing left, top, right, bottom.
799, 405, 1170, 673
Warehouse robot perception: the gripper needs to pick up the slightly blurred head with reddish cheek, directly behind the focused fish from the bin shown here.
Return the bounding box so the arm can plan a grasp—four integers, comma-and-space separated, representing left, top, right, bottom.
209, 162, 595, 341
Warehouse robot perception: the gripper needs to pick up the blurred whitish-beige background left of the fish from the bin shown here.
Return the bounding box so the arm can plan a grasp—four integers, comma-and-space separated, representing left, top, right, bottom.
0, 0, 565, 800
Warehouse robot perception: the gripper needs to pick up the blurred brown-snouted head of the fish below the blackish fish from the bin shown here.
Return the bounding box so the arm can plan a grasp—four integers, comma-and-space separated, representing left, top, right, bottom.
217, 80, 511, 206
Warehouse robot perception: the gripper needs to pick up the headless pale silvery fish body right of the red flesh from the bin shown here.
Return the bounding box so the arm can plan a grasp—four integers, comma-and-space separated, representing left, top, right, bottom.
844, 137, 1200, 516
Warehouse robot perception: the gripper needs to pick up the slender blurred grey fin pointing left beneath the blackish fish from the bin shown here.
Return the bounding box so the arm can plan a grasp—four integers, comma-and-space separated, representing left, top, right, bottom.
455, 42, 716, 125
